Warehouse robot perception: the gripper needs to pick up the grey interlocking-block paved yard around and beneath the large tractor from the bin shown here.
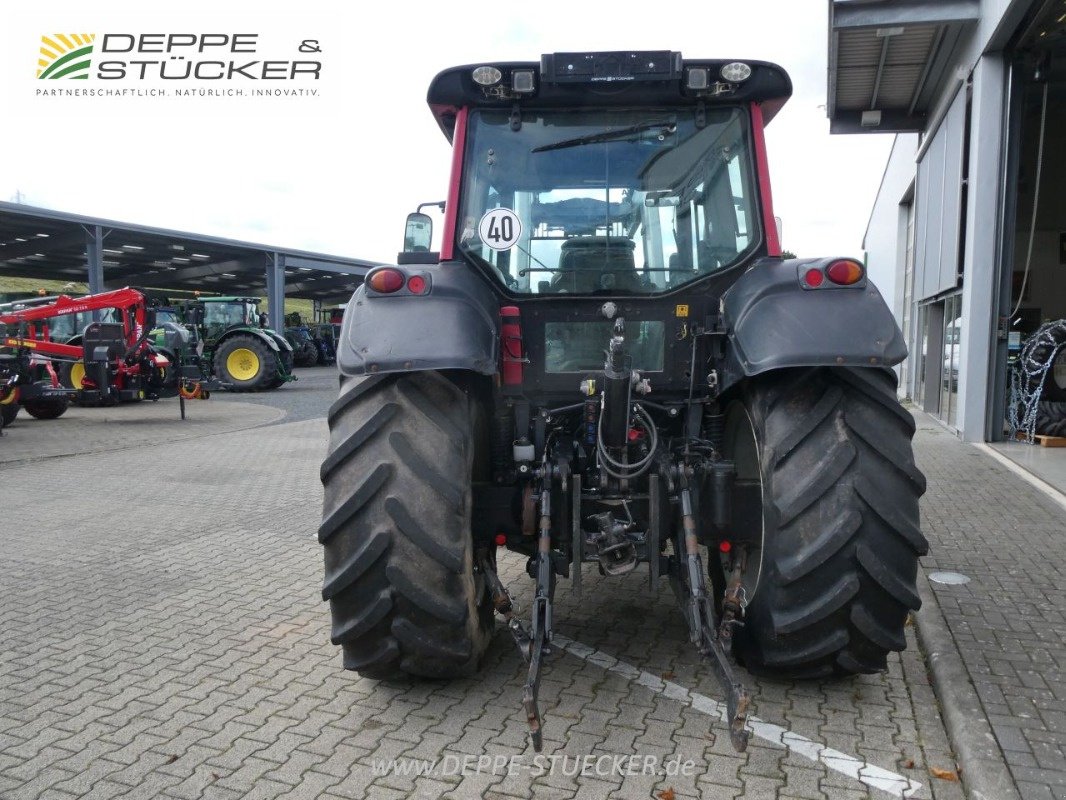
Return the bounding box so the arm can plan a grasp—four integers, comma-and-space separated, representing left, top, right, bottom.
0, 369, 1040, 800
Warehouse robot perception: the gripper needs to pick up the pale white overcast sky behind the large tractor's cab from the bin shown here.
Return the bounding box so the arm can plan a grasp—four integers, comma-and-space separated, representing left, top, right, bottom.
0, 0, 892, 267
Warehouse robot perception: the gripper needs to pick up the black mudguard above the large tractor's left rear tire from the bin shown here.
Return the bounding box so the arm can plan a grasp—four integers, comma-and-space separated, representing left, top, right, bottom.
337, 262, 500, 375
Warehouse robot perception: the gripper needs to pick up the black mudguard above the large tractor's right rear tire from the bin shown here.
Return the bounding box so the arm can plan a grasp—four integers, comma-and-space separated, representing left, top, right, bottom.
722, 258, 907, 389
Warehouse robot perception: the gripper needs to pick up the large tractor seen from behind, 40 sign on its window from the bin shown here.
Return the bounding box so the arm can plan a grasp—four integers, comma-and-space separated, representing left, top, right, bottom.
319, 51, 927, 750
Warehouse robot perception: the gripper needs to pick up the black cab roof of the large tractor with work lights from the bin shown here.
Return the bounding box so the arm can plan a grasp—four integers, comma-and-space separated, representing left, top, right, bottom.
426, 50, 792, 141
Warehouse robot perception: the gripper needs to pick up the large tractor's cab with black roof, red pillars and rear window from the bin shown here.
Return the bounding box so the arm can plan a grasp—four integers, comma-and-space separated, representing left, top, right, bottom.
420, 51, 791, 297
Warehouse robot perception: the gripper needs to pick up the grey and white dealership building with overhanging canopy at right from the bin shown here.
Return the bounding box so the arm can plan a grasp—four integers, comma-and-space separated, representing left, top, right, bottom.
827, 0, 1066, 445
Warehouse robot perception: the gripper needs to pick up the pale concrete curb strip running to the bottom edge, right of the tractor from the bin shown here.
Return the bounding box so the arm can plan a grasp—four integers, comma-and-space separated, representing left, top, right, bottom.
915, 569, 1021, 800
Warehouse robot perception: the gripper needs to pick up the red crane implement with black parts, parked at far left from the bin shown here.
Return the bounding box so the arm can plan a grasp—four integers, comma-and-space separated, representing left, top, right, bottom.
0, 288, 203, 422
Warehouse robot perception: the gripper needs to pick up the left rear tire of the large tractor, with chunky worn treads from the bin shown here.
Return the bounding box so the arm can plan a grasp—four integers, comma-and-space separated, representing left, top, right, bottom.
319, 372, 494, 678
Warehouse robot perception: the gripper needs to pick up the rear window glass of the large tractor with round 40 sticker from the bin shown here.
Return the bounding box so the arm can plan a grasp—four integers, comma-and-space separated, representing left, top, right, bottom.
457, 108, 760, 294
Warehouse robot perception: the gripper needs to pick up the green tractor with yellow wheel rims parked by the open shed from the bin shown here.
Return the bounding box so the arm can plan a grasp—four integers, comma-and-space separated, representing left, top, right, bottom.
156, 297, 296, 391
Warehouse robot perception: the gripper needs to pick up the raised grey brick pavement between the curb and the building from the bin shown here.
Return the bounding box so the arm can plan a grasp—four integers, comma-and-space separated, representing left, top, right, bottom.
915, 416, 1066, 800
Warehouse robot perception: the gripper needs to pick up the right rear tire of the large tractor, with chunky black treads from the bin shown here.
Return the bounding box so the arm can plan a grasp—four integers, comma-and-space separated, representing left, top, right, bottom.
726, 368, 928, 677
